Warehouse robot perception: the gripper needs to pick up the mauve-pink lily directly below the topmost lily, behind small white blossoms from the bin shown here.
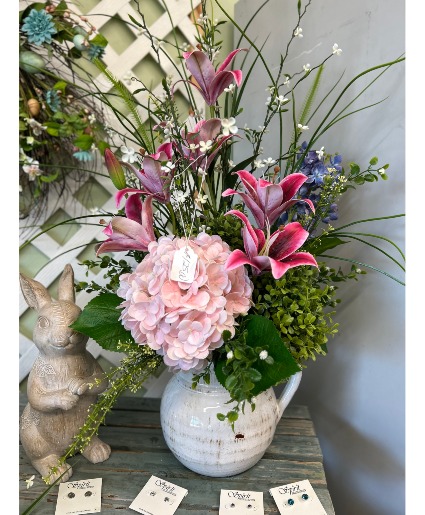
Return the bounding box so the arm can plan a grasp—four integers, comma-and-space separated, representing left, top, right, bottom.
181, 118, 233, 170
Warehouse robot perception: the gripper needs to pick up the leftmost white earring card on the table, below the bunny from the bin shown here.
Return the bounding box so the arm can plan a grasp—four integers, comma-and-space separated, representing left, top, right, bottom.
55, 477, 102, 515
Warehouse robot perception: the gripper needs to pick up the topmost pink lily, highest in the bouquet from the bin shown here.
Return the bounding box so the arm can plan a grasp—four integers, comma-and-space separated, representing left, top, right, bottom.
183, 48, 246, 106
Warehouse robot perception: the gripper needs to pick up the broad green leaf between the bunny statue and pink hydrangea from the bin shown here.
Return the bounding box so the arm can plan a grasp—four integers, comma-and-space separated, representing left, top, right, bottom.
70, 293, 134, 352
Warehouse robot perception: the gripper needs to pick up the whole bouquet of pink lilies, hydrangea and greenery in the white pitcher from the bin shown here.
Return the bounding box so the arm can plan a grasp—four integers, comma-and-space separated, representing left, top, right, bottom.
29, 1, 404, 468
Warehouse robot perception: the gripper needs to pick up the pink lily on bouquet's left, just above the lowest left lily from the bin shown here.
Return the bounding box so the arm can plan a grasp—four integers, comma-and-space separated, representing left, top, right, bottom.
115, 143, 173, 206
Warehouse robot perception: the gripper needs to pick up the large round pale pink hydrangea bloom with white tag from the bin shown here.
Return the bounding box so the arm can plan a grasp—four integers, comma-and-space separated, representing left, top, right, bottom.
117, 232, 253, 370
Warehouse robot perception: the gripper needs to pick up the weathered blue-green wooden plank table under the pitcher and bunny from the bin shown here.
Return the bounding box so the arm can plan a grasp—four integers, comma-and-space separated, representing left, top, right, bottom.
19, 397, 335, 515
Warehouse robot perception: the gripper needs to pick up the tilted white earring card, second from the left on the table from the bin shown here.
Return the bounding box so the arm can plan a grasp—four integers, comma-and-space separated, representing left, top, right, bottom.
130, 476, 187, 515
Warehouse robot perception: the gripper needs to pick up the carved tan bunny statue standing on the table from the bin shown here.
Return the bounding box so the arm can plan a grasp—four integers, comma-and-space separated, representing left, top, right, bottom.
20, 264, 111, 483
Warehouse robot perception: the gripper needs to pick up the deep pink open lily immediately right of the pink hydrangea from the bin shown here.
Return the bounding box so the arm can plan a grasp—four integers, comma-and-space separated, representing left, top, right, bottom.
225, 210, 318, 279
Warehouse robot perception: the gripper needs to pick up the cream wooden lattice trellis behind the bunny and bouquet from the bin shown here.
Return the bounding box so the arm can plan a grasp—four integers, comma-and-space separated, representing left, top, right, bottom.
19, 0, 202, 396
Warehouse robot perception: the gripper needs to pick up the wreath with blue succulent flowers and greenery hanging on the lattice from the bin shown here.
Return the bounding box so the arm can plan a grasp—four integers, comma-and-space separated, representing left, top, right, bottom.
19, 1, 109, 221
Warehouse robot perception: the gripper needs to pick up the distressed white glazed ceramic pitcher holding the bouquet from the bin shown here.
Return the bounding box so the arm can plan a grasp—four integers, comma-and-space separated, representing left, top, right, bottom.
160, 371, 302, 477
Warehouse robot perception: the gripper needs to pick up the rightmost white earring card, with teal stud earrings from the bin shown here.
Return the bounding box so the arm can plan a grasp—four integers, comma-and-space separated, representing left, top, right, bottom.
269, 479, 326, 515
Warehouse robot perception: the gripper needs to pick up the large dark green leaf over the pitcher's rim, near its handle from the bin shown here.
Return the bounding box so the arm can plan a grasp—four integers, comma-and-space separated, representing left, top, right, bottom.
215, 315, 300, 395
